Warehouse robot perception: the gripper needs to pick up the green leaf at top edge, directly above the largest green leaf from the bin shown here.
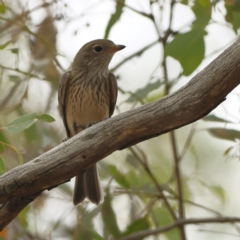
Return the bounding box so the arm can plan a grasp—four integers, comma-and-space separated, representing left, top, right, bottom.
192, 0, 212, 28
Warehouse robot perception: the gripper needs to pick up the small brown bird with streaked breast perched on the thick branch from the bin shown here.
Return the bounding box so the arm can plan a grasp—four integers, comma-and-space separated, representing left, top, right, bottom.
58, 39, 125, 206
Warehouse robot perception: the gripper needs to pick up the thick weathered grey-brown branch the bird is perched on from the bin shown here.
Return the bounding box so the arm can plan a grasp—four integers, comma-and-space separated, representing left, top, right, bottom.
0, 40, 240, 229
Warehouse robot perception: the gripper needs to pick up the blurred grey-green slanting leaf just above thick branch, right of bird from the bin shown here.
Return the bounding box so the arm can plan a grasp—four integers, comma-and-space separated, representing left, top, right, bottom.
126, 81, 161, 102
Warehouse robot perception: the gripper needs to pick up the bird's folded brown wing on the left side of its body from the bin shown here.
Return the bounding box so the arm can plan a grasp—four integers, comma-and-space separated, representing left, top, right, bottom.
58, 72, 70, 138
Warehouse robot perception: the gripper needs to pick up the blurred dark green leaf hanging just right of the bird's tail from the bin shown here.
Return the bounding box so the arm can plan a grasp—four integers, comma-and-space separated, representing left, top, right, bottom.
102, 191, 121, 238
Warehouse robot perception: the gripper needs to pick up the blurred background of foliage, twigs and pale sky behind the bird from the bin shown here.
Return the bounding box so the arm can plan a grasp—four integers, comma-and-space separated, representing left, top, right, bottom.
0, 0, 240, 240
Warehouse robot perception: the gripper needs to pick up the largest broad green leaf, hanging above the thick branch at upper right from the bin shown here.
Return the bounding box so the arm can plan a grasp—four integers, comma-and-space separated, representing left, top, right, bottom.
165, 29, 206, 76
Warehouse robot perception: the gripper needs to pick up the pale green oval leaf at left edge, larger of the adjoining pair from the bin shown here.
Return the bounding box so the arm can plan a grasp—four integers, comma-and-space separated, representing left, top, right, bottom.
5, 113, 37, 133
